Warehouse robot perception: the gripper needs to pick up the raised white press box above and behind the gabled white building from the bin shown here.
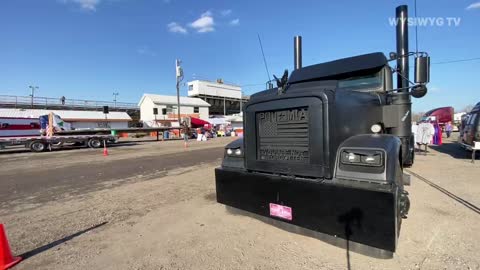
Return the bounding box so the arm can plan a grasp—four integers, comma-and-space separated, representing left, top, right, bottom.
188, 80, 242, 100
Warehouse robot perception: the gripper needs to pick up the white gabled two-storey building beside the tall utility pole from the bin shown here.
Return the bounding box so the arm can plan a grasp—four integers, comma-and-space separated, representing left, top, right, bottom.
138, 94, 210, 126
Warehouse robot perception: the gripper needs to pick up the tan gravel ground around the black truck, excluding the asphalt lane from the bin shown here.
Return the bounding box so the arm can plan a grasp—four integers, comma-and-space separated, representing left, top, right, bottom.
0, 137, 480, 269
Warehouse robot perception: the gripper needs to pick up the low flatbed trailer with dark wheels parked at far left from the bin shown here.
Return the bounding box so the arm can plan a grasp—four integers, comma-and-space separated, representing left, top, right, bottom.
0, 134, 118, 153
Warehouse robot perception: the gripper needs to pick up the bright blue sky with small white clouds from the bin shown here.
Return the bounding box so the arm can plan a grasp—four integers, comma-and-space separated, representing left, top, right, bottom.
0, 0, 480, 111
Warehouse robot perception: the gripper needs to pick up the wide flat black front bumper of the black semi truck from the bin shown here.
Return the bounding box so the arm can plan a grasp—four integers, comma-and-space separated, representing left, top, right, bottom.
215, 168, 399, 252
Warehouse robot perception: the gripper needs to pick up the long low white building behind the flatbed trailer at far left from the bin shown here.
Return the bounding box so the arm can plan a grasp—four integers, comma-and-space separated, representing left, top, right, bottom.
0, 109, 132, 129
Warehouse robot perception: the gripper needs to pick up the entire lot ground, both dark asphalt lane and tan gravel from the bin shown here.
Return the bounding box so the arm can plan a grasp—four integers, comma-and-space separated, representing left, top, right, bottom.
0, 138, 480, 269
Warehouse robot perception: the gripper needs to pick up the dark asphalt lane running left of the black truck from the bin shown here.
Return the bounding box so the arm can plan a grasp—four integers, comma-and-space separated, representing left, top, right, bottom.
0, 142, 224, 208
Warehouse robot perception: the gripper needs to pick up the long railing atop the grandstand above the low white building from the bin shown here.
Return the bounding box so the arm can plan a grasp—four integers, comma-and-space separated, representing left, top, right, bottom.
0, 95, 139, 110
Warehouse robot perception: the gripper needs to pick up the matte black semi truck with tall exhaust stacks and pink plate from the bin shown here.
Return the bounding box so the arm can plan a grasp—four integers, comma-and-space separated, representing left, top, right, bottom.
215, 6, 430, 256
